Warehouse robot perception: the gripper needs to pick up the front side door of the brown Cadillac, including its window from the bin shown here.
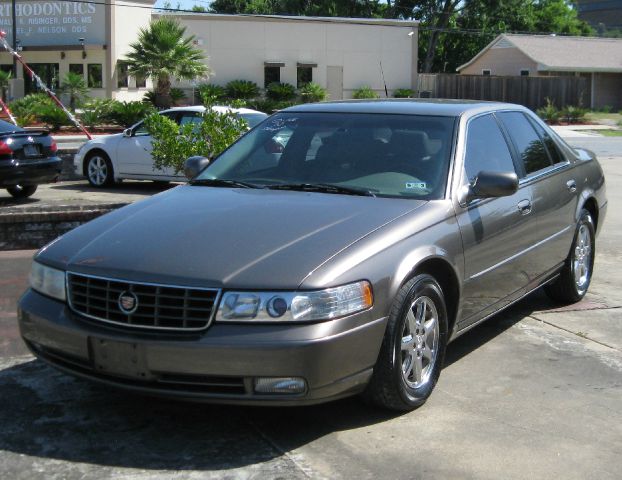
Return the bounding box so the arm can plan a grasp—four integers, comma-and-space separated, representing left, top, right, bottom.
457, 114, 537, 328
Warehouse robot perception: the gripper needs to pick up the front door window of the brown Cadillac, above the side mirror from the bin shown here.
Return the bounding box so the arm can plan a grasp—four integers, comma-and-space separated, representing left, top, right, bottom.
464, 115, 515, 181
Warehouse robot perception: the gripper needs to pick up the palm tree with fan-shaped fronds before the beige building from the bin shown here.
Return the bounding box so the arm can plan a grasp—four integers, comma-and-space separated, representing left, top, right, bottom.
125, 17, 209, 108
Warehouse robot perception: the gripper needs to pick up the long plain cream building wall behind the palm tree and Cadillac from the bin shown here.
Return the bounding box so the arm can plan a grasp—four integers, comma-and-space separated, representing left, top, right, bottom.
168, 15, 416, 98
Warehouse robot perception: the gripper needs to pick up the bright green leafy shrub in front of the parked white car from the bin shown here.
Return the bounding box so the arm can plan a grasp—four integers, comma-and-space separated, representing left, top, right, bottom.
145, 101, 248, 173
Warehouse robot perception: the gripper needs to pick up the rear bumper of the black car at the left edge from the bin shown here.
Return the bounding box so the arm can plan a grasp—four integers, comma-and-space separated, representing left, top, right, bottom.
0, 157, 62, 187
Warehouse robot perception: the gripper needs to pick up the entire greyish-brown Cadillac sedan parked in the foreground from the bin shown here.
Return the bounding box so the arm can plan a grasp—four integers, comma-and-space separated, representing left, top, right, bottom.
18, 100, 607, 410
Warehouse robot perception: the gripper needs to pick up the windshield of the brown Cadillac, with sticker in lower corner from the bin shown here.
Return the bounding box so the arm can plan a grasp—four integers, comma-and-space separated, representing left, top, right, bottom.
200, 112, 455, 199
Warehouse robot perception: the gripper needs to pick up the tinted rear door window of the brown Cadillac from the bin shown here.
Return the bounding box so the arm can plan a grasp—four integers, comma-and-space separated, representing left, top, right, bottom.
498, 112, 551, 174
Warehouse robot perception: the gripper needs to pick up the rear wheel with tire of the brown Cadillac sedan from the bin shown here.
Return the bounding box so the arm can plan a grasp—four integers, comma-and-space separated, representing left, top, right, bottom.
544, 209, 596, 303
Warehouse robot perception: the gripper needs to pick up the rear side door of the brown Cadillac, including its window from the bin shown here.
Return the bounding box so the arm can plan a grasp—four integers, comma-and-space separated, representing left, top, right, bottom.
498, 112, 578, 275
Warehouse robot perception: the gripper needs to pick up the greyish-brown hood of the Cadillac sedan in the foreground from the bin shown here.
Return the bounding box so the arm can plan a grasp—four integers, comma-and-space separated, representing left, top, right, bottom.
38, 185, 425, 289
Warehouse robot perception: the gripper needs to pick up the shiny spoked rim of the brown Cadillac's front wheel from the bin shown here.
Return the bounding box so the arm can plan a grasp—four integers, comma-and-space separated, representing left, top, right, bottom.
401, 297, 439, 388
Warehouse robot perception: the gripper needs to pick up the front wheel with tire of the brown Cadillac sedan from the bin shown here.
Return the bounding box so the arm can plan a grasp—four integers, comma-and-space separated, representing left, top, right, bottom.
363, 275, 447, 412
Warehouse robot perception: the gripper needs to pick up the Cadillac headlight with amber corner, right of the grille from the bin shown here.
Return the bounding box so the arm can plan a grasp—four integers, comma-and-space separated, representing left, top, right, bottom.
216, 281, 374, 322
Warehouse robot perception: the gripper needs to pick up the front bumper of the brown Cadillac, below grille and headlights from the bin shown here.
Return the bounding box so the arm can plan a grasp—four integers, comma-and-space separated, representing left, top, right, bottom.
18, 290, 386, 405
